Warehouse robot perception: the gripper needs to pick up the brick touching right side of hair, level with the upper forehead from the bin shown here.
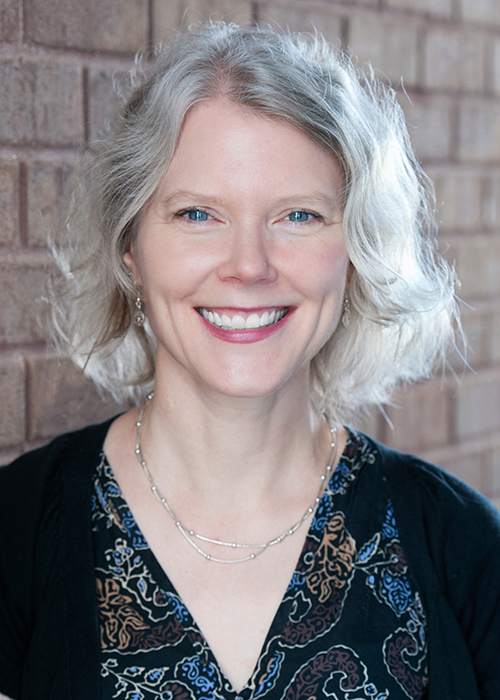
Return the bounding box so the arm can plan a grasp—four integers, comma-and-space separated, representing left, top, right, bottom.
401, 96, 452, 160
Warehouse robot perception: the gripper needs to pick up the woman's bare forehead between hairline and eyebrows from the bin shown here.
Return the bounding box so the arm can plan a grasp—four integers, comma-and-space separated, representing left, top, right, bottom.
156, 99, 342, 206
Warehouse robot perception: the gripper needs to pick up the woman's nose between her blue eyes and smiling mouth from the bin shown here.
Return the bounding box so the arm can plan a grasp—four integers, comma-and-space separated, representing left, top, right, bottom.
219, 224, 277, 284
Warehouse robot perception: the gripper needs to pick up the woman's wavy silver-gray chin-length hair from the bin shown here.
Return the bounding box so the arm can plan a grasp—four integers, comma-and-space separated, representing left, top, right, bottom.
53, 23, 459, 422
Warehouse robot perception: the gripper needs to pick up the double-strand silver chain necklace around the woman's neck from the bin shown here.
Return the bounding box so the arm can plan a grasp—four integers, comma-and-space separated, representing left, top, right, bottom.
135, 392, 337, 564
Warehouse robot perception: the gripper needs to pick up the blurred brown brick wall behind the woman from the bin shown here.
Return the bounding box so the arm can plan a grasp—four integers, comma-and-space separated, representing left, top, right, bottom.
0, 0, 500, 504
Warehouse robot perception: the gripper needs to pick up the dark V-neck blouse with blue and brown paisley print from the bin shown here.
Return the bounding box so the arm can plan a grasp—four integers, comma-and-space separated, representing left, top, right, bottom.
92, 433, 428, 700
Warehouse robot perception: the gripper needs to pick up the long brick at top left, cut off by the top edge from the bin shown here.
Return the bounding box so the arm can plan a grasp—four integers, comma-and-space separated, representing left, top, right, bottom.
25, 0, 147, 52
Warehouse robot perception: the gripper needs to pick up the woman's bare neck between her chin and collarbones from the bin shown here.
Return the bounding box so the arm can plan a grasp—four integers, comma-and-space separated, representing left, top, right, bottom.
142, 360, 328, 502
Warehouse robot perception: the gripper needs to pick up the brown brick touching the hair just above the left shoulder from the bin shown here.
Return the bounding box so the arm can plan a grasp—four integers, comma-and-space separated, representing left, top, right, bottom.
28, 358, 126, 441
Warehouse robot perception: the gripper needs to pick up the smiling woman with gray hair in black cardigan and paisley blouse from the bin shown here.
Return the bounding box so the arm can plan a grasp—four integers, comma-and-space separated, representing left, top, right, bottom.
0, 25, 500, 700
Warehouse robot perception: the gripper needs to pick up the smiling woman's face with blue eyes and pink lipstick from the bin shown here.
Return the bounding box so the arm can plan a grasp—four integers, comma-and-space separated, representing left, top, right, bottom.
124, 99, 349, 397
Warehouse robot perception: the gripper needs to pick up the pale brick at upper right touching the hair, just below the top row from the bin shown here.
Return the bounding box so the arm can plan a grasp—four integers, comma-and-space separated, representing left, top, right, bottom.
348, 15, 418, 85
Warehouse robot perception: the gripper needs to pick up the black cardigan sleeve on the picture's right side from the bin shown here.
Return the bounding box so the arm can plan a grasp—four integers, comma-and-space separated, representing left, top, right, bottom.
382, 446, 500, 700
